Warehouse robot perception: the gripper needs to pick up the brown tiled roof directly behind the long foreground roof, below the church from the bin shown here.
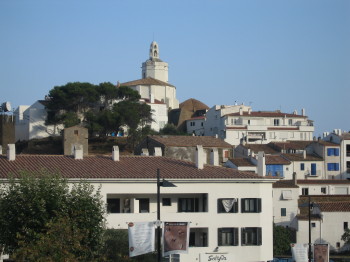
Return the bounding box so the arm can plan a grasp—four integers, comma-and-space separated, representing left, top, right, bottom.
148, 136, 233, 148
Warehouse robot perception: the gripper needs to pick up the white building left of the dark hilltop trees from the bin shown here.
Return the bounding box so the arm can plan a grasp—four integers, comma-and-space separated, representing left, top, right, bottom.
15, 101, 63, 141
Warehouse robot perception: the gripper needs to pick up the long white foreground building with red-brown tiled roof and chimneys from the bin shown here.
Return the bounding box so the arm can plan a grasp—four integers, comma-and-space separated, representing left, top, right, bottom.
0, 146, 276, 262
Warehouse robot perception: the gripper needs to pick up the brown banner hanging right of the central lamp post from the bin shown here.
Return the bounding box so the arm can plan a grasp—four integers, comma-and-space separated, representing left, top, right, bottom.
163, 222, 190, 256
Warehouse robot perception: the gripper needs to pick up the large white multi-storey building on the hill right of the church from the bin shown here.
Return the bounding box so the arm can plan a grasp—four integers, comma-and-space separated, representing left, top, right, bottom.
204, 104, 314, 145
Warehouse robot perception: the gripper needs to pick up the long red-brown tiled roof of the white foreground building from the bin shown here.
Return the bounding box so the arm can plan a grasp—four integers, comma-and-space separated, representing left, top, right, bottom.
0, 155, 274, 179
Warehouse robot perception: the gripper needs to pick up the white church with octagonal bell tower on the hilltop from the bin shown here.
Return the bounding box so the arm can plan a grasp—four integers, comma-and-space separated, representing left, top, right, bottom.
120, 41, 179, 111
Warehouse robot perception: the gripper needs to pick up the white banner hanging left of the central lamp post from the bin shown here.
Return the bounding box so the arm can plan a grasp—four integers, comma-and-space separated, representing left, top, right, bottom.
128, 222, 155, 257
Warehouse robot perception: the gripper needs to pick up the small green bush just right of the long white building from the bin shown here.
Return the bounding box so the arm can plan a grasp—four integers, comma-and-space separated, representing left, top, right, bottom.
273, 224, 292, 256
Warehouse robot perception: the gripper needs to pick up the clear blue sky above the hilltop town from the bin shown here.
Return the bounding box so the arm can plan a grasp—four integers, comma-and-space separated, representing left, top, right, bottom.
0, 0, 350, 136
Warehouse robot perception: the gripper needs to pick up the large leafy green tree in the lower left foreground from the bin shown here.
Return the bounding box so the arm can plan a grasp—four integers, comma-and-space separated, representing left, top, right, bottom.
0, 170, 105, 261
